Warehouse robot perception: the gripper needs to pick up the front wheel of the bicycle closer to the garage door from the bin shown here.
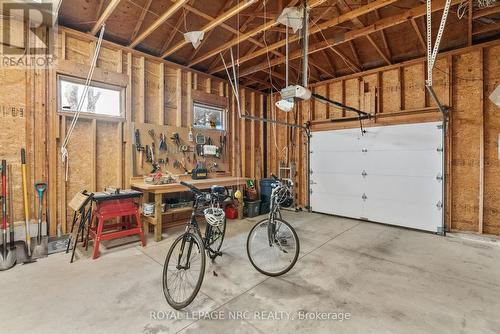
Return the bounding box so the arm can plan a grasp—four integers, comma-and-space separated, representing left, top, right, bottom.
247, 219, 300, 276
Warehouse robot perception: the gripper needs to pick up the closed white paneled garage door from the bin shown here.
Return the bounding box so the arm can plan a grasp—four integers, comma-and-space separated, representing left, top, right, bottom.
311, 122, 442, 232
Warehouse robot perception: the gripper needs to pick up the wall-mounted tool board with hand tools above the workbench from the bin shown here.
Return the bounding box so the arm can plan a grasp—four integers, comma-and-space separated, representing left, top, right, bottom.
129, 123, 231, 176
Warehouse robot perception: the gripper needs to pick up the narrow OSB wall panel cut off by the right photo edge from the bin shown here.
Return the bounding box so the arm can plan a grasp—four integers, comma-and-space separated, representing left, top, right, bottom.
484, 46, 500, 235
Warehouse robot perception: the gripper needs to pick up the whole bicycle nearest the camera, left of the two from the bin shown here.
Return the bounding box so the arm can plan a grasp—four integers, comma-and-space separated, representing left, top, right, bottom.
163, 182, 228, 310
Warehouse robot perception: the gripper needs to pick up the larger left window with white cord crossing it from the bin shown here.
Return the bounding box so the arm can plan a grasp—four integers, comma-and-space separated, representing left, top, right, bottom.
58, 76, 124, 117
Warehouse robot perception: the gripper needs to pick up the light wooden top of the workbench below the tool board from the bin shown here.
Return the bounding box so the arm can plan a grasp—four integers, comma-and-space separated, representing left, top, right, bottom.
130, 176, 247, 194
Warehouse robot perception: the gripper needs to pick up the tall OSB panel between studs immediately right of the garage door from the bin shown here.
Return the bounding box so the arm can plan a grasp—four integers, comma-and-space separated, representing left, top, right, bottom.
451, 51, 482, 231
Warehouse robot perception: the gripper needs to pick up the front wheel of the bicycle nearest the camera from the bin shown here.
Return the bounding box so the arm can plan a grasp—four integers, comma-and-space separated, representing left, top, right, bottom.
163, 232, 205, 310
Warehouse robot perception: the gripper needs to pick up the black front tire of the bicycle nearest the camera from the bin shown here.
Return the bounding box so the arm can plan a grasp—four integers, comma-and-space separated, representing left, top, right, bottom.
162, 232, 206, 310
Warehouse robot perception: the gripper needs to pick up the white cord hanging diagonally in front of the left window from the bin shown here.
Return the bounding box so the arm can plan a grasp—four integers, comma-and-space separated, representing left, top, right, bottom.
61, 24, 106, 181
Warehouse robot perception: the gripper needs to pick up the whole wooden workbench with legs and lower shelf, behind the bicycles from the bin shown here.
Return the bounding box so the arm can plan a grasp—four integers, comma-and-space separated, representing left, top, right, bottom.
130, 176, 246, 241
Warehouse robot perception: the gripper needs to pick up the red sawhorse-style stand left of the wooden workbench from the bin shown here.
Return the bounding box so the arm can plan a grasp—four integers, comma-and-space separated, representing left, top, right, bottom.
87, 194, 146, 259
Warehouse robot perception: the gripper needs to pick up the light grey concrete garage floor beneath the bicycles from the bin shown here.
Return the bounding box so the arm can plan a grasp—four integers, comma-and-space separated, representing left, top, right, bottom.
0, 213, 500, 334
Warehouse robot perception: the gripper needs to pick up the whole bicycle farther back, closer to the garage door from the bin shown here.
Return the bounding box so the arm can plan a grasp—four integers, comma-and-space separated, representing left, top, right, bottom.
247, 175, 300, 276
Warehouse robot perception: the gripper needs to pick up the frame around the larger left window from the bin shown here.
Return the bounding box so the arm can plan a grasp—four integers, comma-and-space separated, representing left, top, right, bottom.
56, 74, 126, 122
